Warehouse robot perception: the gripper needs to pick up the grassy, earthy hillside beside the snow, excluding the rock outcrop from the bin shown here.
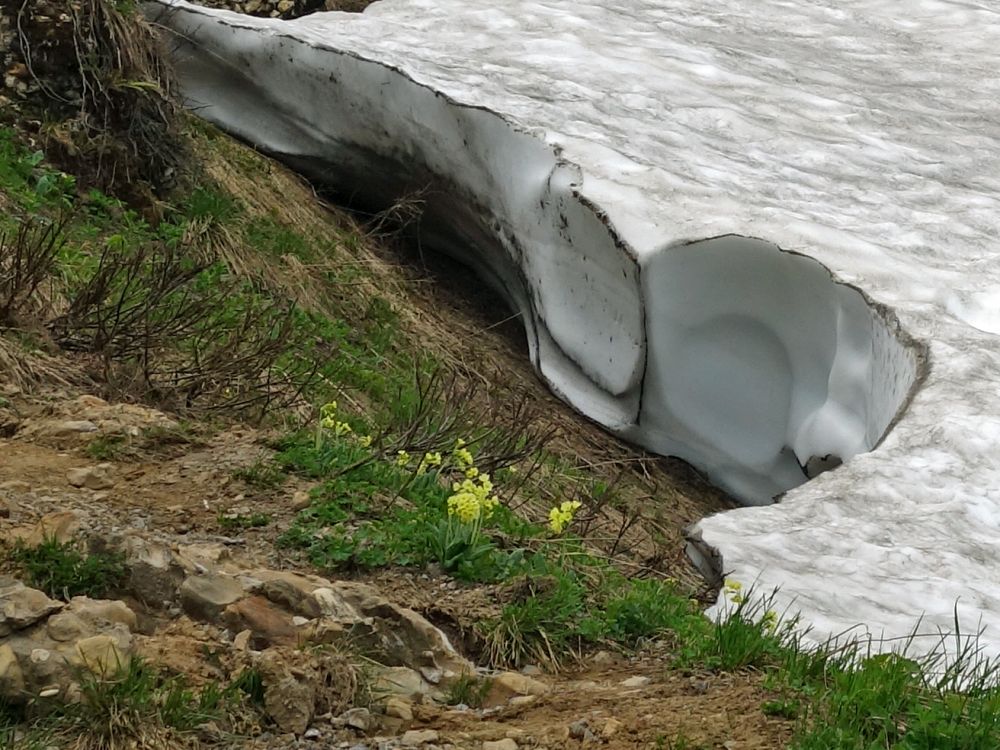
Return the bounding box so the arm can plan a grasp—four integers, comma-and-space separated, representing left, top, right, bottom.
0, 0, 1000, 750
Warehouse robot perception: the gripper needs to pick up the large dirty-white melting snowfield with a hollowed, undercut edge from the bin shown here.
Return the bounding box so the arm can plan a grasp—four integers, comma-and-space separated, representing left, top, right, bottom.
148, 0, 1000, 651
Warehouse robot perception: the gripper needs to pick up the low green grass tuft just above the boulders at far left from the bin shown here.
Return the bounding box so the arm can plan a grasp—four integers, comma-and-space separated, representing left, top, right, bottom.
10, 538, 128, 599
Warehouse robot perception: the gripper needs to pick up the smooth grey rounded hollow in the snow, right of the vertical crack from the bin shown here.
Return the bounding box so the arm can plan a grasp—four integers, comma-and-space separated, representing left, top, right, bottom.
634, 235, 919, 504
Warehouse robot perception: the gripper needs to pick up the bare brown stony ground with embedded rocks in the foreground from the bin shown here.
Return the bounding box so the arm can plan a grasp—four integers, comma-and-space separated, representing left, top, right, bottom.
0, 385, 790, 750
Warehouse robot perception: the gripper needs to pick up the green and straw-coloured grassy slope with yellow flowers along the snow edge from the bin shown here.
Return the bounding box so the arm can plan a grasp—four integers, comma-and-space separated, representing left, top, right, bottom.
0, 114, 1000, 749
